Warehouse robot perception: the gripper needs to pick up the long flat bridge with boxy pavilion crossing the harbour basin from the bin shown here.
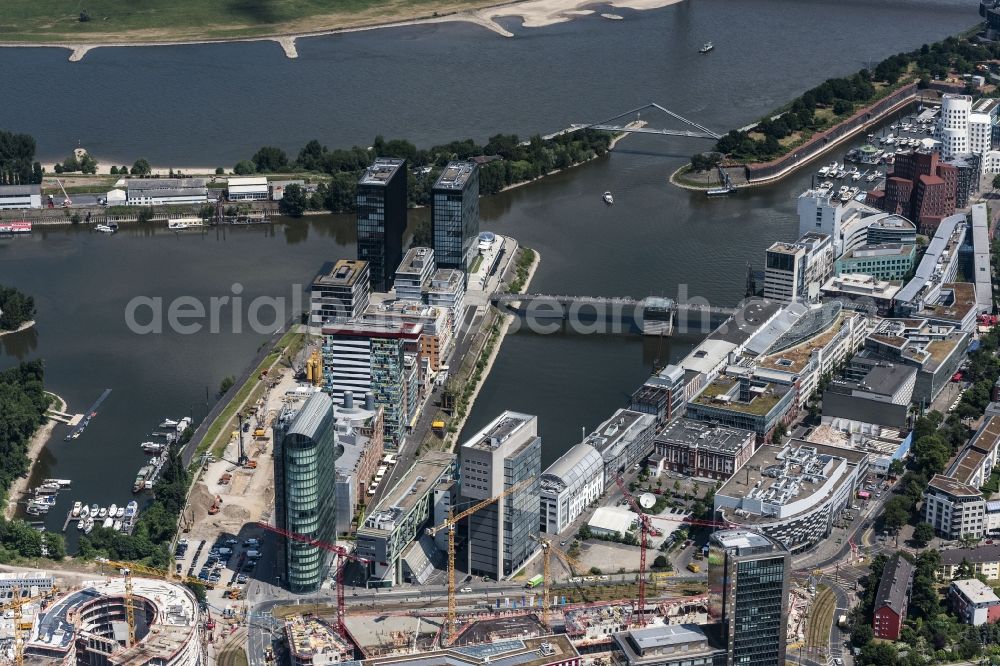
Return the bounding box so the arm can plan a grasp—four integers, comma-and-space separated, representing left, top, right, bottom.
490, 293, 736, 335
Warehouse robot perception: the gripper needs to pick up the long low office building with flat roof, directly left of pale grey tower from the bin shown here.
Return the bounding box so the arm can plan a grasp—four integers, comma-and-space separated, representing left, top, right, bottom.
357, 451, 456, 587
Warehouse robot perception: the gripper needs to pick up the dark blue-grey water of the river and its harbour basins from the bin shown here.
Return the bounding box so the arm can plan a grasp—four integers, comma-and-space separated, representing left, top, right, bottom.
0, 0, 977, 527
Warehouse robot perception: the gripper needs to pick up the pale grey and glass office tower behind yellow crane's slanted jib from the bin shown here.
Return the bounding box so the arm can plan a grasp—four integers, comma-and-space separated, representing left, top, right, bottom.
459, 411, 542, 580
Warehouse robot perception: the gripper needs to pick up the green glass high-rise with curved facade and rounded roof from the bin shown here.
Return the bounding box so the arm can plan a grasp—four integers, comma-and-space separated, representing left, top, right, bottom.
274, 392, 337, 594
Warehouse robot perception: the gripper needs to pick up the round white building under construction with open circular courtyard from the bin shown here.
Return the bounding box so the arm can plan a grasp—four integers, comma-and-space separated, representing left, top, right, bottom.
25, 575, 205, 666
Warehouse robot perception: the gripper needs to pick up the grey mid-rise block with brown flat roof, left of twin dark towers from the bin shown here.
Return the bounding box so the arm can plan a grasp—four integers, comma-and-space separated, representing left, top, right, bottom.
309, 259, 371, 326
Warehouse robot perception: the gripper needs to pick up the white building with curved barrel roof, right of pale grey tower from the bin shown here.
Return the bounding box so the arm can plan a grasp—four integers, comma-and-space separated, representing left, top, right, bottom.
538, 442, 604, 534
